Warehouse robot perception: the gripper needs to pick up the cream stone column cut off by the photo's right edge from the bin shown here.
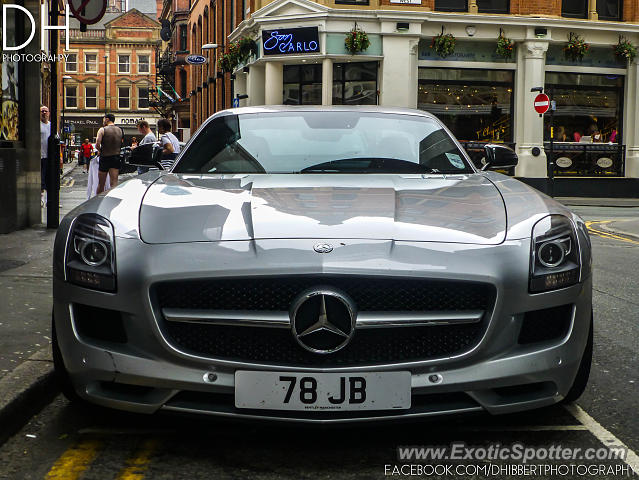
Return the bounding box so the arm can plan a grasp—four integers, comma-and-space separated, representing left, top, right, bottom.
621, 59, 639, 178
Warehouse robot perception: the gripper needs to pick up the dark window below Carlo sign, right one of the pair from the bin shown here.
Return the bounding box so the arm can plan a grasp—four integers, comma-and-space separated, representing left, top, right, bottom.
333, 62, 377, 105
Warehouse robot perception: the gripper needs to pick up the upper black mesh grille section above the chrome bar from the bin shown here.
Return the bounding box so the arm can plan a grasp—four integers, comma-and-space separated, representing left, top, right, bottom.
155, 276, 495, 312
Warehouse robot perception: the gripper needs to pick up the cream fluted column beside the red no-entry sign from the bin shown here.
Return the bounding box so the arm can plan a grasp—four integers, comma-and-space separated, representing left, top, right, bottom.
515, 40, 548, 178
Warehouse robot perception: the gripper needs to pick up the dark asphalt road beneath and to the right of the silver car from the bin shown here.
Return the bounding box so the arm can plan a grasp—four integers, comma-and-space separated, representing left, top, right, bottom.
0, 170, 639, 480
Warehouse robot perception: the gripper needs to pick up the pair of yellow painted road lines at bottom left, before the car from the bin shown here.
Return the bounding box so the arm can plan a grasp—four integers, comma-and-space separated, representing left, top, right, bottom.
45, 438, 159, 480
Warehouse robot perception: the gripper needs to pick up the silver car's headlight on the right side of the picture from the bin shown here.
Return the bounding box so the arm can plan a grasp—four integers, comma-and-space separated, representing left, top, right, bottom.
529, 215, 581, 293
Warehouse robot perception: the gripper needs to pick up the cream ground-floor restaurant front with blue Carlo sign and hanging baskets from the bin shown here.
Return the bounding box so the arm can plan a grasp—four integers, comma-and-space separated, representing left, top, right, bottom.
230, 0, 639, 195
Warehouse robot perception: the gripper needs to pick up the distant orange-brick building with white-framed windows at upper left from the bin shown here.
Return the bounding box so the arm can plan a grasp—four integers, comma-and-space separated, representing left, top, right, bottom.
58, 8, 160, 140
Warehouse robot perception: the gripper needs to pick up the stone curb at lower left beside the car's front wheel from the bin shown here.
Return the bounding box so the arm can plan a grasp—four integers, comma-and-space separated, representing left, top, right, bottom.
0, 346, 58, 445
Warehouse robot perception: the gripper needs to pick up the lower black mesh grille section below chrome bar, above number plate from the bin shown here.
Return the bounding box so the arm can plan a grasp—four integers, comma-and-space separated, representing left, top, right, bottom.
164, 322, 485, 367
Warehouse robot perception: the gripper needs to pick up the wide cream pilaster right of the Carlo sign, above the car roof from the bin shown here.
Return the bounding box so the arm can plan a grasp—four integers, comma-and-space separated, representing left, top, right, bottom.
379, 35, 419, 108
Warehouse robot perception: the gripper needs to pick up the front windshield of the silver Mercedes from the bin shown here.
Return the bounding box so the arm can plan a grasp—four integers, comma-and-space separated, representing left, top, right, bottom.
173, 111, 473, 174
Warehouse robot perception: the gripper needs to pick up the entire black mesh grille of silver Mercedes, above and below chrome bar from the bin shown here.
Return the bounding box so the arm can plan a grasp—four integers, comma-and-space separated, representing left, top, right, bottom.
152, 276, 495, 367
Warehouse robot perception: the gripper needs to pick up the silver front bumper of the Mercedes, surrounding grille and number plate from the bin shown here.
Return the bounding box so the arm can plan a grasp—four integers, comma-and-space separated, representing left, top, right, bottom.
54, 239, 592, 423
